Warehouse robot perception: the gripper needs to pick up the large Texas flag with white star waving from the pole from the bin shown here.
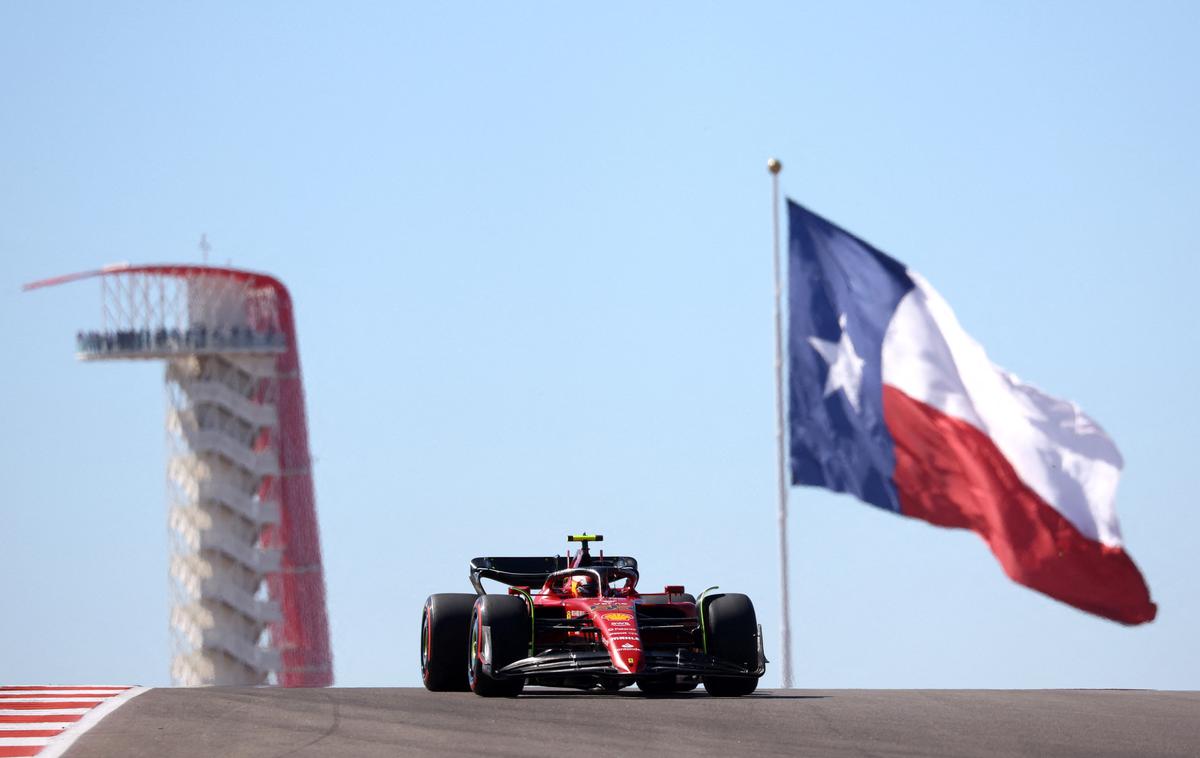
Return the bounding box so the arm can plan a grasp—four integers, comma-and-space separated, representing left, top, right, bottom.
788, 201, 1157, 624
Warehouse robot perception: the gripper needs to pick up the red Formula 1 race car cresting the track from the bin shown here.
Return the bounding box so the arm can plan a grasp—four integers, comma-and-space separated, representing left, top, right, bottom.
421, 535, 767, 697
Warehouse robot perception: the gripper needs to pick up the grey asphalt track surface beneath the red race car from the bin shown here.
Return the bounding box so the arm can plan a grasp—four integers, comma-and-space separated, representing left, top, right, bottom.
66, 687, 1200, 758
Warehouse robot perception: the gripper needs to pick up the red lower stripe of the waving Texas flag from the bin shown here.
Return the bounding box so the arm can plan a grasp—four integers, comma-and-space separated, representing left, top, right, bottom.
883, 385, 1158, 624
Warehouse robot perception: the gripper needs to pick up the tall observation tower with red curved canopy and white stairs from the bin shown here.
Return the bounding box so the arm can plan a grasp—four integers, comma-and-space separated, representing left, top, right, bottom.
25, 264, 334, 687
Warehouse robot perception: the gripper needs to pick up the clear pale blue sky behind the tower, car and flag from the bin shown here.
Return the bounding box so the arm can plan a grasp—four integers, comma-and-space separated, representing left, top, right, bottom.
0, 2, 1200, 688
